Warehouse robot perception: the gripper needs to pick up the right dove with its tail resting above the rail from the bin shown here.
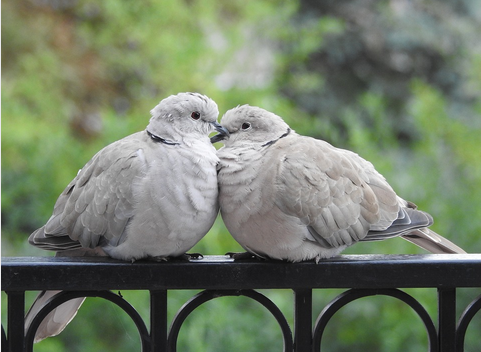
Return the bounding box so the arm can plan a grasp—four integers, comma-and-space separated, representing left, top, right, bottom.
211, 105, 465, 262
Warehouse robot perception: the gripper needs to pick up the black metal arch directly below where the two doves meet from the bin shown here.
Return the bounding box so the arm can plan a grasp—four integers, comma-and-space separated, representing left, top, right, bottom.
167, 290, 294, 352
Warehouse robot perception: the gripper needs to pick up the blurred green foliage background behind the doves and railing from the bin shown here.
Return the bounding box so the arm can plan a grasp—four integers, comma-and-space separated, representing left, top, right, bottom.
1, 0, 481, 352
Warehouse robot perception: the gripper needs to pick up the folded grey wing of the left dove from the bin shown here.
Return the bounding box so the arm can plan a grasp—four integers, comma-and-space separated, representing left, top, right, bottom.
29, 133, 145, 250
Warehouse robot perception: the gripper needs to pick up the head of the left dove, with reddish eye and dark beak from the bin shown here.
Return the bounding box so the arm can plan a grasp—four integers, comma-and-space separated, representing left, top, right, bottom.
147, 93, 226, 141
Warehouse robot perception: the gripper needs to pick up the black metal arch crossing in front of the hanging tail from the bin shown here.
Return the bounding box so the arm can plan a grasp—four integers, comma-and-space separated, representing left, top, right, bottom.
25, 291, 150, 351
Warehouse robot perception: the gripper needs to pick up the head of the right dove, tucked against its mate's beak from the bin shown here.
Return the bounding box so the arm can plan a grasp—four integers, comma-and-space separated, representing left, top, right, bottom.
211, 105, 291, 146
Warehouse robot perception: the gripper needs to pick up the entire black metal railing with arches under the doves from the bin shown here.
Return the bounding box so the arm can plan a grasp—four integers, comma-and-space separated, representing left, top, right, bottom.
2, 254, 481, 352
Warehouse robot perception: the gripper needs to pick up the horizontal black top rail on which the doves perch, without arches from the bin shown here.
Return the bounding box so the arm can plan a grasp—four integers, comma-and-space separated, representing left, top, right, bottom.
2, 254, 481, 291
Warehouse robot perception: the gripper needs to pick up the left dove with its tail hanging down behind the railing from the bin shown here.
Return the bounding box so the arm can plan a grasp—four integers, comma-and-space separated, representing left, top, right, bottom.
25, 93, 227, 342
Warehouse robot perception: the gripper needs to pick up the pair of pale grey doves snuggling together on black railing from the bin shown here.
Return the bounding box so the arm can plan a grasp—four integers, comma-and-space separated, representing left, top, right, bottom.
26, 93, 464, 342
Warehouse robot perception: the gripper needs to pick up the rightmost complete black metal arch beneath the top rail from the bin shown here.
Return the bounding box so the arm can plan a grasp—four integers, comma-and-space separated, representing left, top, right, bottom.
313, 288, 438, 351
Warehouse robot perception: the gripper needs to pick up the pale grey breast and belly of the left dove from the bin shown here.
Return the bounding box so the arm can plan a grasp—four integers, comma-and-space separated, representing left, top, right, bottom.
104, 130, 219, 259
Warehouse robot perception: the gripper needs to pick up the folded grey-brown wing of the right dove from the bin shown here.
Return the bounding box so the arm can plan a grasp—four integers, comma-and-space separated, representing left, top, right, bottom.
276, 135, 399, 248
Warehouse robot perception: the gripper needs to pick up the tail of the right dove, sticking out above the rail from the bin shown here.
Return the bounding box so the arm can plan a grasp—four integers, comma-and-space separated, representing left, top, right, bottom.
402, 227, 466, 254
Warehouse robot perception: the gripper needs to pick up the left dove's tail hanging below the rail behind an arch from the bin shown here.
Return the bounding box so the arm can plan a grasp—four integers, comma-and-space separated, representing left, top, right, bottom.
25, 291, 85, 343
